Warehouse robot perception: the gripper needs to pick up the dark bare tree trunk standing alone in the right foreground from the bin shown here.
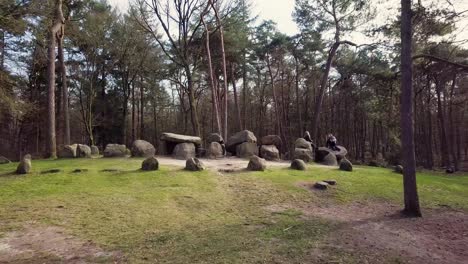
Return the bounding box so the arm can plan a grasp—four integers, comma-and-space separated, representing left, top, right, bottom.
401, 0, 421, 217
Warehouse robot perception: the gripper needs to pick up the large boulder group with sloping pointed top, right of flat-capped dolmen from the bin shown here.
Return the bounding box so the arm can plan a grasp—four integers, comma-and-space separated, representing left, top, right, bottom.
226, 130, 258, 158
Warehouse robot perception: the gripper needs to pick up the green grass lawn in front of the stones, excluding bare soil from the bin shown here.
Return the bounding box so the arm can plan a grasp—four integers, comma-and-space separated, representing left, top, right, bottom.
0, 159, 468, 263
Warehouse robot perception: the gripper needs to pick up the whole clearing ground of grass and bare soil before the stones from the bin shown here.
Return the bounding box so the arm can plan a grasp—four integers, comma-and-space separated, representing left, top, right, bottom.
0, 158, 468, 263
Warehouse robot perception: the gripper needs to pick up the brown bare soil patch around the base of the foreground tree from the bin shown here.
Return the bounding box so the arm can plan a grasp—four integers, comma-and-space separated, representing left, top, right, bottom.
268, 202, 468, 264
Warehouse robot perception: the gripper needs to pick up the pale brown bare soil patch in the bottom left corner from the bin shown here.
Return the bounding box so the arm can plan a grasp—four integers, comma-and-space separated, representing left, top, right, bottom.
0, 225, 123, 264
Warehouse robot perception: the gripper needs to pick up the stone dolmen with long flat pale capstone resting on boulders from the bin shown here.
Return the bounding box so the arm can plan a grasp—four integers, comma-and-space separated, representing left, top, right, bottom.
160, 133, 202, 160
